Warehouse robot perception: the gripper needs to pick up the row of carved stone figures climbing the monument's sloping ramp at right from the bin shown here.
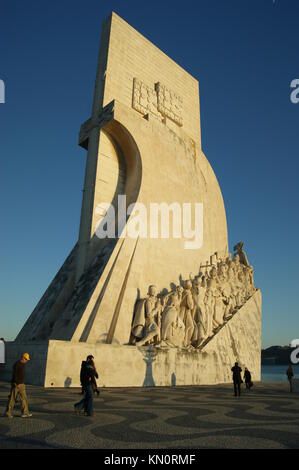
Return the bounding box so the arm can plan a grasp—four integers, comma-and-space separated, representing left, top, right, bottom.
131, 242, 256, 349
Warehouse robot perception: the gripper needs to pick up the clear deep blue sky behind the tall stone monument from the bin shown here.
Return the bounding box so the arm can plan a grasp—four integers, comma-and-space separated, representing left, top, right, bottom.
0, 0, 299, 347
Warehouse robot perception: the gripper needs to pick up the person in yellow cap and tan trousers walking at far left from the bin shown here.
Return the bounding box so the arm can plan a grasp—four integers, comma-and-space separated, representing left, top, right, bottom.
5, 353, 32, 418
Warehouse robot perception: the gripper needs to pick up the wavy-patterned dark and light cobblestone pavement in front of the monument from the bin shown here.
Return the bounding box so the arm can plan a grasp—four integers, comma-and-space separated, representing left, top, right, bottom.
0, 382, 299, 449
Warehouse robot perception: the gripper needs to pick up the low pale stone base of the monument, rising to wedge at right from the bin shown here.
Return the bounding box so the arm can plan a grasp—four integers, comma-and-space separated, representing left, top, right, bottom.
2, 290, 261, 387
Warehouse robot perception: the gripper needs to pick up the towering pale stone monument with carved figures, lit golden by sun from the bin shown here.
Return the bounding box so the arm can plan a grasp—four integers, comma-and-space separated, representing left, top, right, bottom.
6, 13, 261, 387
